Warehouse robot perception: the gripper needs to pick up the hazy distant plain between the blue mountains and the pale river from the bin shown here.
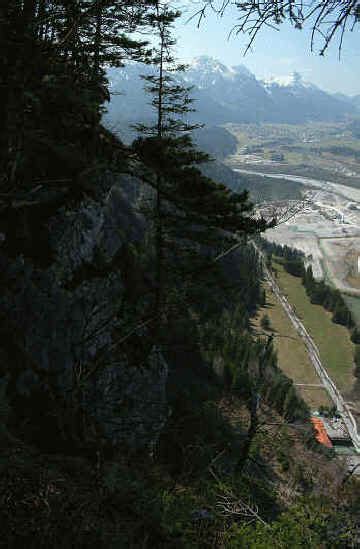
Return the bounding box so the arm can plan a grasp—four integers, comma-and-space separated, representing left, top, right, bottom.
226, 122, 360, 188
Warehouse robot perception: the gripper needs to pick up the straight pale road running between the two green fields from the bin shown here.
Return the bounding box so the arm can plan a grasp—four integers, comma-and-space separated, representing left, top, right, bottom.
256, 247, 360, 453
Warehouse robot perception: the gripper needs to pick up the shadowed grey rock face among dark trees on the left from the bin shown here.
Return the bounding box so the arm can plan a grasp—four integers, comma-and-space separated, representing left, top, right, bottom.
0, 176, 167, 451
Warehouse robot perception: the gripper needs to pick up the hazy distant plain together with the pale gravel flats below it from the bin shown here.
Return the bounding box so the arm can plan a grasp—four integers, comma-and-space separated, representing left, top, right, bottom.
226, 123, 360, 326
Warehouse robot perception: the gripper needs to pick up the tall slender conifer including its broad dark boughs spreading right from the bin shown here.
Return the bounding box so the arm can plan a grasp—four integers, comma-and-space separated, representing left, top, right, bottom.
134, 2, 265, 322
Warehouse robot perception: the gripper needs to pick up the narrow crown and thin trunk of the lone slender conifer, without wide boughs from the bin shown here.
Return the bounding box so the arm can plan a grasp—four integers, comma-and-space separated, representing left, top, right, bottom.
135, 2, 202, 314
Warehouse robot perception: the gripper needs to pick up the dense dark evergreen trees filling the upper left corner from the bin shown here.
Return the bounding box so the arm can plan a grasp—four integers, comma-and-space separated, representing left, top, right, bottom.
0, 0, 151, 199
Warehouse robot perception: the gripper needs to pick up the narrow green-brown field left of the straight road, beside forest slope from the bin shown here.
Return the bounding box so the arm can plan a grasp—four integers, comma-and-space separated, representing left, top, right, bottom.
254, 289, 332, 410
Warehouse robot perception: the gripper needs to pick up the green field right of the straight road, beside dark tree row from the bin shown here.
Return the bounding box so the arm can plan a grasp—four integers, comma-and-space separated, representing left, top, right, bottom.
274, 263, 356, 396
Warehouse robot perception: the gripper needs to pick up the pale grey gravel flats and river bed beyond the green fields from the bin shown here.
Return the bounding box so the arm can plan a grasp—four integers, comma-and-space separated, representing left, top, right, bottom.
231, 169, 360, 325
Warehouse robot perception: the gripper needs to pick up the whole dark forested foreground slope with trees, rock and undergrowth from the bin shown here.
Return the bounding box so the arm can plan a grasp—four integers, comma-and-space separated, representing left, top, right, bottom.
0, 0, 359, 548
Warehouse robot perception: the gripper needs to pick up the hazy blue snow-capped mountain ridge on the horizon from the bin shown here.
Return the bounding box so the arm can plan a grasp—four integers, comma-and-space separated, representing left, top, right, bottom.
105, 56, 360, 130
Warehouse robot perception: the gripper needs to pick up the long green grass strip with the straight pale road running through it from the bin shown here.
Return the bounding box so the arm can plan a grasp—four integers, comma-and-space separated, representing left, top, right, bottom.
255, 255, 360, 468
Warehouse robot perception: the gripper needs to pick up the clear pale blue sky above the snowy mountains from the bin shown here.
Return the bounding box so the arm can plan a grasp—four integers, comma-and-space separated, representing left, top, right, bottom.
175, 2, 360, 95
